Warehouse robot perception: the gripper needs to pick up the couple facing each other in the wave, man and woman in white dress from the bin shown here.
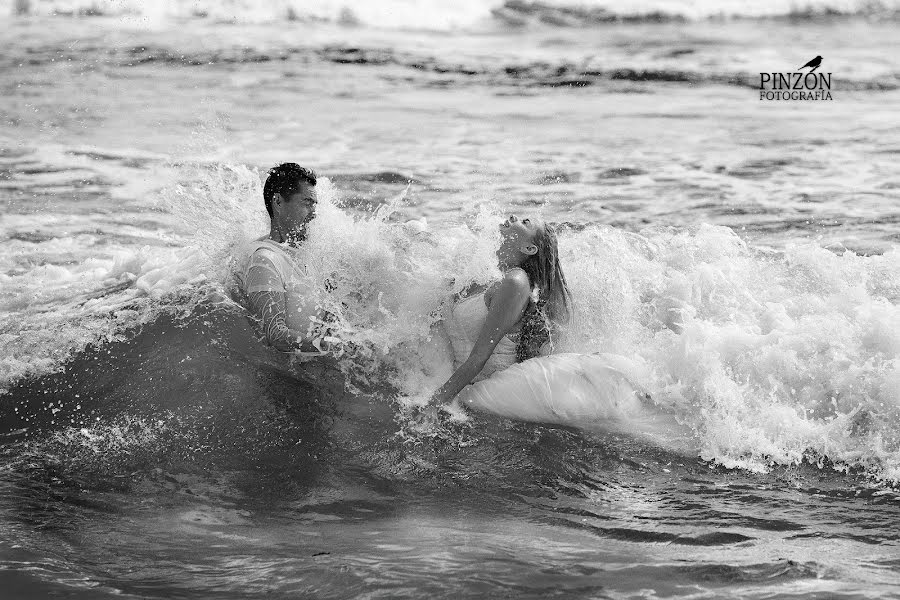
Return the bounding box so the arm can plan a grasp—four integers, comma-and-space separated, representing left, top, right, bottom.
238, 163, 668, 434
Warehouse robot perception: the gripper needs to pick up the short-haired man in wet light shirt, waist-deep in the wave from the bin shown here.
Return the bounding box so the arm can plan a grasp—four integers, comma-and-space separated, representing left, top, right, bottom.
240, 163, 321, 352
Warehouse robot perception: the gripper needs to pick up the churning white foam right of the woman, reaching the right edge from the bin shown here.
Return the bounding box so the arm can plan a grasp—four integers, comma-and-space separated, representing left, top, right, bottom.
564, 226, 900, 476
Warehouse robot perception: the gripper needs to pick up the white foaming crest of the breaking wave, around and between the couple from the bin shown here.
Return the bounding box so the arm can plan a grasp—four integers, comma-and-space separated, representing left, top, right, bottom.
0, 165, 900, 480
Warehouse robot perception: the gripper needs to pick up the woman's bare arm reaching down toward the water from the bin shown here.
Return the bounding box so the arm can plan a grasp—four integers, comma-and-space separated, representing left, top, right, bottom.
431, 269, 531, 404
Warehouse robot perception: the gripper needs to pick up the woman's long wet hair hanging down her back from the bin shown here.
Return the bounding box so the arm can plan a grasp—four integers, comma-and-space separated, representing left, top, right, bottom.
516, 220, 572, 362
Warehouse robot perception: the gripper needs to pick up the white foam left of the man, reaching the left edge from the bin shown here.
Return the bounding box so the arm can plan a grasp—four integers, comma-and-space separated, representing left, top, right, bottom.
0, 159, 265, 392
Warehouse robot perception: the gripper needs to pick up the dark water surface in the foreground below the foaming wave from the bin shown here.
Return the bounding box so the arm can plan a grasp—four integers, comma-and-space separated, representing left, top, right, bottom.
0, 311, 900, 598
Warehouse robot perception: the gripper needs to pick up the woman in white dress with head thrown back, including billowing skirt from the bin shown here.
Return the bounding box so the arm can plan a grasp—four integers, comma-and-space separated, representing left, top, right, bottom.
431, 215, 672, 437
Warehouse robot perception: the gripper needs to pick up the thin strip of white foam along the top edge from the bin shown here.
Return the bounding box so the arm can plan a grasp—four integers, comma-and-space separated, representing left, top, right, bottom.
0, 0, 900, 30
